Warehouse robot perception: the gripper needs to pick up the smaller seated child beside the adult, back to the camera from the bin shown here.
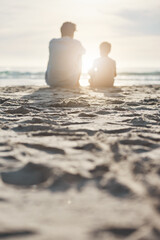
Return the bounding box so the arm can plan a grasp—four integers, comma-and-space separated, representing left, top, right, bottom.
89, 42, 117, 87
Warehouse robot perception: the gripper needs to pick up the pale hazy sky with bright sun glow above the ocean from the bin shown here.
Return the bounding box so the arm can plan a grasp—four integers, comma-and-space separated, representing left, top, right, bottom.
0, 0, 160, 71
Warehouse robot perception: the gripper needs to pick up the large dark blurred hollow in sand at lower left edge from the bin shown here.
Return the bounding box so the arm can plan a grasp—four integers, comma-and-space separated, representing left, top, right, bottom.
1, 162, 51, 186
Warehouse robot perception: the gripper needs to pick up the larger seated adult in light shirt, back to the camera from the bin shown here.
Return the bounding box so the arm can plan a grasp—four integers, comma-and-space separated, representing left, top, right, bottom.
45, 22, 85, 87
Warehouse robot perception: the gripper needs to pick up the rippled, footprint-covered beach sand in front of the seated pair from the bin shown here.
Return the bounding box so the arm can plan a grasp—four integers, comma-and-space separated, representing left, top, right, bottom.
0, 86, 160, 240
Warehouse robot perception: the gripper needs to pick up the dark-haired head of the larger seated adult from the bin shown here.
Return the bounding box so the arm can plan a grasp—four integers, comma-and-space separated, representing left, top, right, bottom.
61, 22, 76, 38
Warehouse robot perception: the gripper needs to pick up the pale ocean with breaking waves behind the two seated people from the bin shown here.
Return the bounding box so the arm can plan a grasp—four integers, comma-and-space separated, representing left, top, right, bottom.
0, 67, 160, 87
